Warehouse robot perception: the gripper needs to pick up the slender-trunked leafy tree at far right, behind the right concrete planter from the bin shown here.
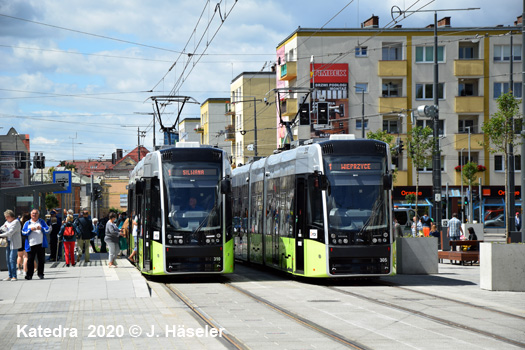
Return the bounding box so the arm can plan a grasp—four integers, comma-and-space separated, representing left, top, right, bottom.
481, 92, 523, 241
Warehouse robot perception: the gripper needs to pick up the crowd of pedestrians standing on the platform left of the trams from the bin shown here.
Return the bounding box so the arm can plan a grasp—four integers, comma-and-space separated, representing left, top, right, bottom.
0, 209, 129, 281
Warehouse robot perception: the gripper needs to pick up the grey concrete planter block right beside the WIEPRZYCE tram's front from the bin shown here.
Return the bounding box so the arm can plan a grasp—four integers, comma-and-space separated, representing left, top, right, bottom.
396, 237, 438, 275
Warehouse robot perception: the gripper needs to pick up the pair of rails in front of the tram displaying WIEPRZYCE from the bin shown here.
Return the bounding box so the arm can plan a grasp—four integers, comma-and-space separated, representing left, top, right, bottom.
326, 283, 525, 348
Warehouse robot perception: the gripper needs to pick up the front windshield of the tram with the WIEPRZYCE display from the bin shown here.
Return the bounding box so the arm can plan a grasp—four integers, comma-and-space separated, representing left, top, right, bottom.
325, 156, 388, 244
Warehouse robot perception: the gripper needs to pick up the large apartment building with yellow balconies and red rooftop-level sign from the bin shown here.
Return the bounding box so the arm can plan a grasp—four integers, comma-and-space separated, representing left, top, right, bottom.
276, 16, 523, 221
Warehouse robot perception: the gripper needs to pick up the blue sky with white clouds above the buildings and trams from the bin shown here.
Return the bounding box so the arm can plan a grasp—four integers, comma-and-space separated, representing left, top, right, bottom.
0, 0, 523, 166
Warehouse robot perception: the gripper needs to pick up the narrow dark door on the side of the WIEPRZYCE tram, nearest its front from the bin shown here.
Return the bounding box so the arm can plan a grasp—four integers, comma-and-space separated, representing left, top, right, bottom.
294, 177, 307, 273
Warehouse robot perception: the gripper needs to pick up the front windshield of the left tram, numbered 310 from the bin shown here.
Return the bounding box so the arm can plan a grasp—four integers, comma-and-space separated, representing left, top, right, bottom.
163, 162, 221, 233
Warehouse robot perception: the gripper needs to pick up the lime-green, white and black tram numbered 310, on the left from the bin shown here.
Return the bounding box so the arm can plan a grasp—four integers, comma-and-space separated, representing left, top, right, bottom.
128, 143, 234, 275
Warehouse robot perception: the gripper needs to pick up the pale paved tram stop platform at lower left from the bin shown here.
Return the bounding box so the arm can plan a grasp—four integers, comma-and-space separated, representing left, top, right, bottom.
0, 253, 231, 349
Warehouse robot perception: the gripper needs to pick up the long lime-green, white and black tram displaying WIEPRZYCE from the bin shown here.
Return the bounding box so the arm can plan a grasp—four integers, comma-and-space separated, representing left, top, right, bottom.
233, 137, 392, 277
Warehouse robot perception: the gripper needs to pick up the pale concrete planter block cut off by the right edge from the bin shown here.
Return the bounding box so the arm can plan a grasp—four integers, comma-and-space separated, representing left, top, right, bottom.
479, 243, 525, 292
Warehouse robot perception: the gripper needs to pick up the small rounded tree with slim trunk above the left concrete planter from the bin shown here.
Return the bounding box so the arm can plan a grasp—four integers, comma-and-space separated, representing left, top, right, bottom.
407, 126, 434, 215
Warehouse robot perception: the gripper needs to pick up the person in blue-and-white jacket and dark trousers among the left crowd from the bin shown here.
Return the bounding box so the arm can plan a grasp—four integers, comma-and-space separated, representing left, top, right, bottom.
22, 209, 50, 280
